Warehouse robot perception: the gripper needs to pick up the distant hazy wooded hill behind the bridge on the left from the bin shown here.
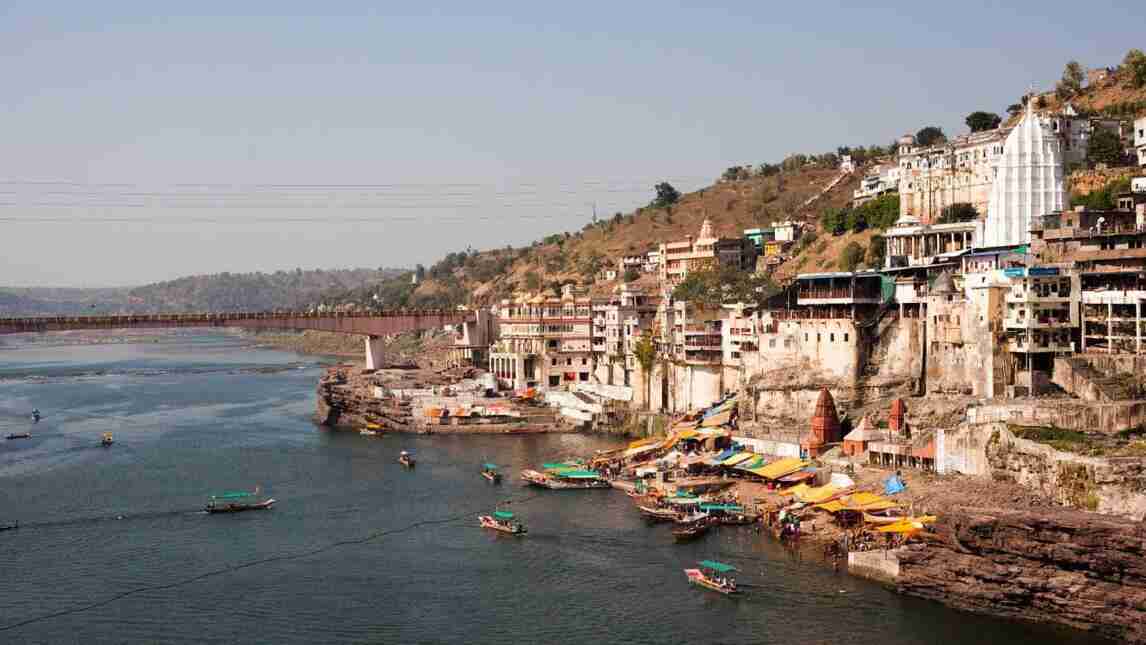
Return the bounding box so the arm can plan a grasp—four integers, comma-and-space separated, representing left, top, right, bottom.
0, 268, 409, 316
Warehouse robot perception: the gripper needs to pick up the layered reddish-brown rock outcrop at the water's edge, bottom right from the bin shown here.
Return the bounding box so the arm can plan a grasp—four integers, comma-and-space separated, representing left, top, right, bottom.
896, 509, 1146, 643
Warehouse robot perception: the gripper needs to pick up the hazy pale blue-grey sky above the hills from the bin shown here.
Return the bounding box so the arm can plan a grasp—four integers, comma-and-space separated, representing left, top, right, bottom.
0, 0, 1146, 286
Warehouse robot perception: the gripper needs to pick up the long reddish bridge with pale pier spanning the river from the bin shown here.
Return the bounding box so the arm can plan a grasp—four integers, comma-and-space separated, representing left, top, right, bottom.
0, 309, 477, 369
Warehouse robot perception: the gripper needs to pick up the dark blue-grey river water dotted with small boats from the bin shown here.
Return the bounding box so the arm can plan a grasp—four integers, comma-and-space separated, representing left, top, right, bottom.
0, 333, 1109, 645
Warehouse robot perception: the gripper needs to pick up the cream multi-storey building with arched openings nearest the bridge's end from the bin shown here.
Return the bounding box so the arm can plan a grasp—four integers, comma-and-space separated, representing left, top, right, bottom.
489, 285, 596, 388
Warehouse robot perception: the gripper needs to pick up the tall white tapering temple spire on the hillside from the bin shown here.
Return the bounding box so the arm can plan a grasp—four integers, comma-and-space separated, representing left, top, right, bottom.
976, 101, 1066, 246
